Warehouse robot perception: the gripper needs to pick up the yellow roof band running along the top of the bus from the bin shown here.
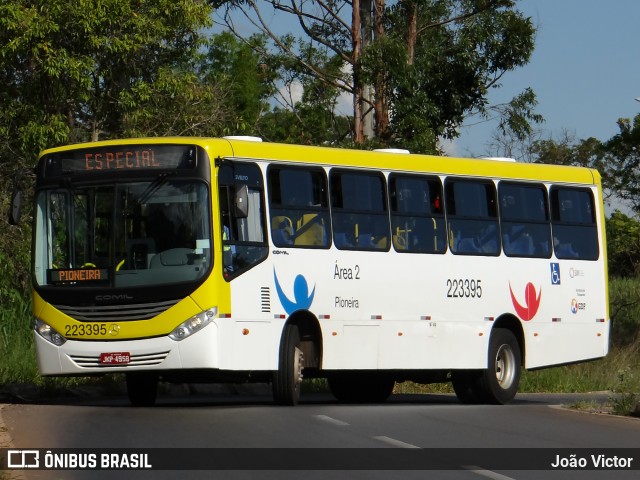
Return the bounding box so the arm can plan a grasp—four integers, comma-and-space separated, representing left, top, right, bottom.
41, 137, 600, 188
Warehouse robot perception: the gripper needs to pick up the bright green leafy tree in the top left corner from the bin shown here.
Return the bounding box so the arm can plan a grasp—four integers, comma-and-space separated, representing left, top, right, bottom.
0, 0, 215, 165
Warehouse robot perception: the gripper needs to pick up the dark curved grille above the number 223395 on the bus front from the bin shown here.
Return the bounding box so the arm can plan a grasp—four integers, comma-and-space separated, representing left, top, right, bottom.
54, 300, 179, 322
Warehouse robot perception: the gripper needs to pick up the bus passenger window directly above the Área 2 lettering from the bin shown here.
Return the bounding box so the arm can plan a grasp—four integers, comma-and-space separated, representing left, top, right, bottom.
330, 170, 390, 251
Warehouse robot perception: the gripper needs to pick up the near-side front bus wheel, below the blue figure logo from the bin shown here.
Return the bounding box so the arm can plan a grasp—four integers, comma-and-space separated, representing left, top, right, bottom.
273, 325, 304, 405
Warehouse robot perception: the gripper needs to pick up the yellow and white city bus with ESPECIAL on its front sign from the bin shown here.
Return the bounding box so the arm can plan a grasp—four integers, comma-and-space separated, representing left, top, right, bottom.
23, 137, 609, 405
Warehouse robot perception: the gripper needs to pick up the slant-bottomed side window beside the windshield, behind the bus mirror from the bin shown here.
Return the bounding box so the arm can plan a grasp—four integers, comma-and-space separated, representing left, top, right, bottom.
218, 160, 269, 280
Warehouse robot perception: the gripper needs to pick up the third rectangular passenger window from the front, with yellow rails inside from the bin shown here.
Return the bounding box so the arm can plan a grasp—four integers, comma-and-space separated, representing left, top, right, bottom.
389, 175, 447, 253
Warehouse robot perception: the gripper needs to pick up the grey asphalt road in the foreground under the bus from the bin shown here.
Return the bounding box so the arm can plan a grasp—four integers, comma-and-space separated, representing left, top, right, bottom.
2, 394, 640, 480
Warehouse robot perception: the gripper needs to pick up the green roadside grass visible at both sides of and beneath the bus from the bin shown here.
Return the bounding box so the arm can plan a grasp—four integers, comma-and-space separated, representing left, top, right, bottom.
0, 279, 640, 415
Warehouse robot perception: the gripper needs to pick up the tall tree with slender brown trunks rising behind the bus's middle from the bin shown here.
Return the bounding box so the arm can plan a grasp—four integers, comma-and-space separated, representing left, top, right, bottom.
211, 0, 541, 152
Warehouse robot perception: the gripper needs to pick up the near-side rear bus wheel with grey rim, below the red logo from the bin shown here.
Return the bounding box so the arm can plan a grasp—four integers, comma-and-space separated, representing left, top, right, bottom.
479, 328, 522, 405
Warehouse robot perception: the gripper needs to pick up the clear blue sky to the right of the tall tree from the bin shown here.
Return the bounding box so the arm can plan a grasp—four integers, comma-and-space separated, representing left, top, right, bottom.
450, 0, 640, 156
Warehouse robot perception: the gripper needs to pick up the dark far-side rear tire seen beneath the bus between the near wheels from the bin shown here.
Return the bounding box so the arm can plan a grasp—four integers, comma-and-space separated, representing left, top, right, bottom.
327, 372, 395, 403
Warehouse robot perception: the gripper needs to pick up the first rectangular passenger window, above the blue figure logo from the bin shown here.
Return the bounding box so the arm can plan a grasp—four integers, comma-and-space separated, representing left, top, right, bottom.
267, 166, 330, 248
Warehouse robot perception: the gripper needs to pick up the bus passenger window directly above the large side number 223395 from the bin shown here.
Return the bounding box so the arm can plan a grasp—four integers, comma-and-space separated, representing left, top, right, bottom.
445, 179, 500, 255
